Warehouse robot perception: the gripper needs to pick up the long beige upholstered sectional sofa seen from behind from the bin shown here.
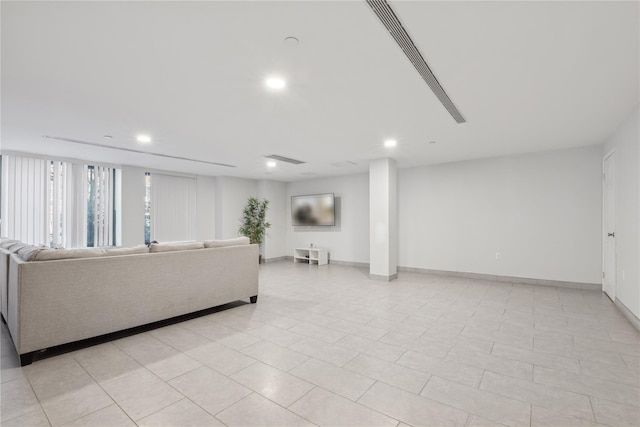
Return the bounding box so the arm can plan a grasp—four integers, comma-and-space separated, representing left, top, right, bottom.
3, 239, 258, 365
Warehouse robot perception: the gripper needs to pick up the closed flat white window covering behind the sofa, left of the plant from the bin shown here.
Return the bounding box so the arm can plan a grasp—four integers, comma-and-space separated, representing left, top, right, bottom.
151, 173, 196, 242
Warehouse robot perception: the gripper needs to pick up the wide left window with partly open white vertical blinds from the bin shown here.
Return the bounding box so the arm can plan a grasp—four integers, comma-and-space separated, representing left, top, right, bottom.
1, 155, 120, 247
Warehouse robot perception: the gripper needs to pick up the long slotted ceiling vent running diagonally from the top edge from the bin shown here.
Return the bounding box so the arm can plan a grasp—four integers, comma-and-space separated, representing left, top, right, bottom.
367, 0, 466, 123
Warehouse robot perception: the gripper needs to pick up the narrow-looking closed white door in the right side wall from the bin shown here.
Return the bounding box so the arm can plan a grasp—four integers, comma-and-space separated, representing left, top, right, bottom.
602, 153, 616, 302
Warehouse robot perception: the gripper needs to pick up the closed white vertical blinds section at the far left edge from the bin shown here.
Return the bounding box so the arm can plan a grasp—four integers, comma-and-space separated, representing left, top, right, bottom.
2, 155, 51, 245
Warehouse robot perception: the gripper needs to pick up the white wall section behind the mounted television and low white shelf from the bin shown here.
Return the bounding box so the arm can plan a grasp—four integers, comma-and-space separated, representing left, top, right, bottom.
285, 174, 369, 264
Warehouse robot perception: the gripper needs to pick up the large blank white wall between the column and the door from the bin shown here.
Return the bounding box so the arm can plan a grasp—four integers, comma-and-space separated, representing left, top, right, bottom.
398, 147, 602, 283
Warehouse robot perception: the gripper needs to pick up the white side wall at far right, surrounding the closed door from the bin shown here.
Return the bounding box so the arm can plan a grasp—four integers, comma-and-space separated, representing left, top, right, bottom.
601, 107, 640, 317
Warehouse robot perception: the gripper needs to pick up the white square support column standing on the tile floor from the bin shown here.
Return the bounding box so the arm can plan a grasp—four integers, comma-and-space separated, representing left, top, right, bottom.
369, 159, 398, 282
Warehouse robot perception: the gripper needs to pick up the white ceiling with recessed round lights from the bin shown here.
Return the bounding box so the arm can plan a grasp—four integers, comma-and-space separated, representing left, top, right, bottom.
1, 0, 640, 181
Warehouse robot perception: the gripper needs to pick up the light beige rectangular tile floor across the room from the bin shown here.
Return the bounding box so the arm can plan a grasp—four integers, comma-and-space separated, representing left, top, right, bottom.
0, 262, 640, 427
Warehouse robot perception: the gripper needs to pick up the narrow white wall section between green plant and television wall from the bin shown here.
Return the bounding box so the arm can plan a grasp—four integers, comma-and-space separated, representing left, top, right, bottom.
258, 180, 290, 260
